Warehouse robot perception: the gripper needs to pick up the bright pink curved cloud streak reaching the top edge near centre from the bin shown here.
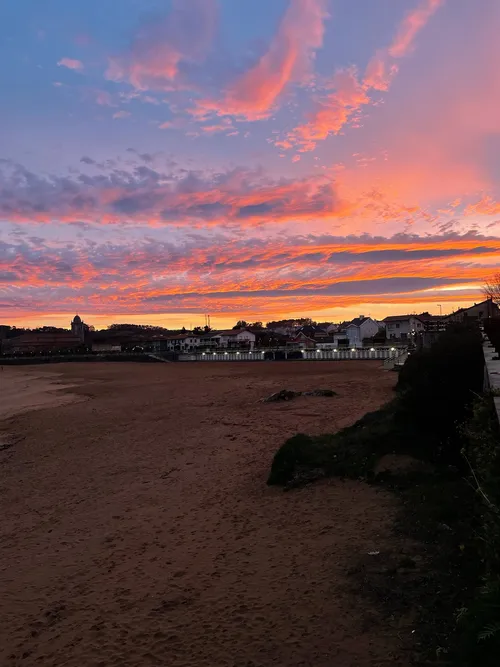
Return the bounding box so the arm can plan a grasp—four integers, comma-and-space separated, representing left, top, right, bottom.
193, 0, 328, 121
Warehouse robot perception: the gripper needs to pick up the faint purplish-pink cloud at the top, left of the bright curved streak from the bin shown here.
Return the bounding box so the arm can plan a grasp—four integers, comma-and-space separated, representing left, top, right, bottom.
106, 0, 216, 91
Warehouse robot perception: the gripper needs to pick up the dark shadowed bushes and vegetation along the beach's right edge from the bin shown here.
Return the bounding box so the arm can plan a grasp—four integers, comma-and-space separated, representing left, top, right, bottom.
268, 325, 500, 667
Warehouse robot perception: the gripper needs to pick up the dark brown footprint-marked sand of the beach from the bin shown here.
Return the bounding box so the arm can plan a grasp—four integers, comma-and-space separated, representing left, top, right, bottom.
0, 362, 407, 667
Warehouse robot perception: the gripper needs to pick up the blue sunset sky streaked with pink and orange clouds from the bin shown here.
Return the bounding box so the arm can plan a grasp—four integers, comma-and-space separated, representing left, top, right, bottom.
0, 0, 500, 327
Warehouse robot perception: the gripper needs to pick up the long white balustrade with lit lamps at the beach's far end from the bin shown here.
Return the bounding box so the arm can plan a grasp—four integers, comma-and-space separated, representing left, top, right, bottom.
179, 347, 406, 361
